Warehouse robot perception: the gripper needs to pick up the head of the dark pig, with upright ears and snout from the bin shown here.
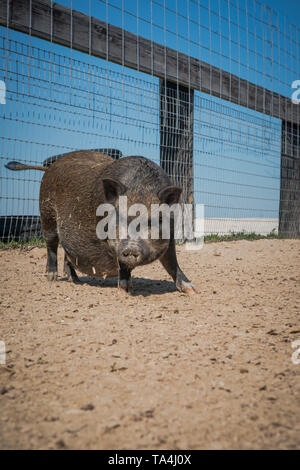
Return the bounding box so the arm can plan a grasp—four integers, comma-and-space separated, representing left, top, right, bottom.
103, 178, 182, 271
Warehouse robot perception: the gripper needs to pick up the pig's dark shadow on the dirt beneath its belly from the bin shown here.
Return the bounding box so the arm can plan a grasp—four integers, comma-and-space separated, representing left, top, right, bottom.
61, 276, 177, 297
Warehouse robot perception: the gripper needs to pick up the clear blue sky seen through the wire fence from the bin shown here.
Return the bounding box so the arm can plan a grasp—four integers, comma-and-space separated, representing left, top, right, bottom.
0, 0, 300, 218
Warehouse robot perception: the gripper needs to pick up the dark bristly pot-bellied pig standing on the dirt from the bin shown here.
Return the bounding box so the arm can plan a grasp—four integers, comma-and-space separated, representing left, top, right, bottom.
6, 150, 198, 294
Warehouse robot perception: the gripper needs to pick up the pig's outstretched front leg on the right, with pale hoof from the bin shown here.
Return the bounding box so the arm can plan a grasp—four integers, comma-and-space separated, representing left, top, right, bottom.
160, 239, 198, 294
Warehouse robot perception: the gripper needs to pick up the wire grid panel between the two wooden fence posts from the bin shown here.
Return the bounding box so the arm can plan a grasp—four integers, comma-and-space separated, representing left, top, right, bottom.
194, 93, 281, 235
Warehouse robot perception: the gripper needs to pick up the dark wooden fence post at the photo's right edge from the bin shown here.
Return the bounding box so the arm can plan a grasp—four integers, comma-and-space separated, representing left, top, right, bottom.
279, 121, 300, 238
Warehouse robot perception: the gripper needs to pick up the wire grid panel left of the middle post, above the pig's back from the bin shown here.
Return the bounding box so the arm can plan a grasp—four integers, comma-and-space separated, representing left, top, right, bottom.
0, 28, 159, 241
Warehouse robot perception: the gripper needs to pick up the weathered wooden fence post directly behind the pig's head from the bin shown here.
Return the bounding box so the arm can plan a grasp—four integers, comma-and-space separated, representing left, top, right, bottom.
159, 79, 194, 204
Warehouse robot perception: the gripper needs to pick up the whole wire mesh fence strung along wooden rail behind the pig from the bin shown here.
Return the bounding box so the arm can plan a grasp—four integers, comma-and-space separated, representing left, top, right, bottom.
0, 0, 300, 241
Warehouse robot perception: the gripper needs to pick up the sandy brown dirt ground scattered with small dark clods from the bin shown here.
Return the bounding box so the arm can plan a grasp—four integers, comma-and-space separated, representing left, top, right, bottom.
0, 240, 300, 449
